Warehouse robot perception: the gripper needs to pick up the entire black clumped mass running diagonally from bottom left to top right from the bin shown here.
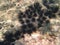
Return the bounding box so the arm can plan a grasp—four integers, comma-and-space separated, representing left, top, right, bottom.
0, 0, 59, 45
